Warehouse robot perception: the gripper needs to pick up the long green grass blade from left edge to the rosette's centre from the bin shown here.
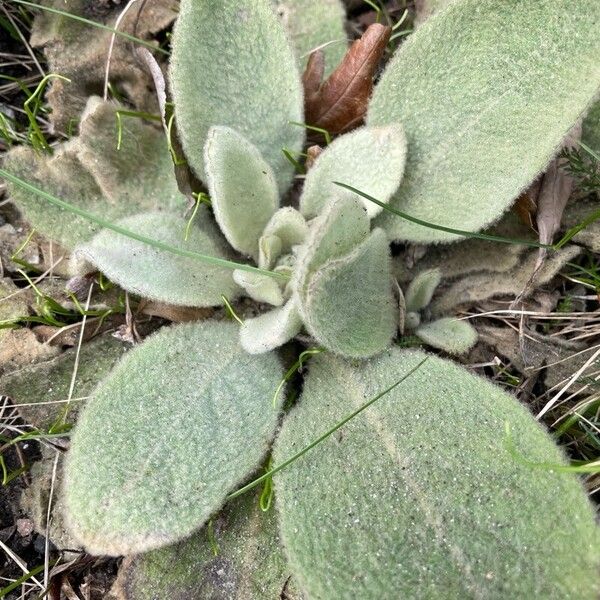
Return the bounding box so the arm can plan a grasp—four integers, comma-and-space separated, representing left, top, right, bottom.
0, 169, 288, 279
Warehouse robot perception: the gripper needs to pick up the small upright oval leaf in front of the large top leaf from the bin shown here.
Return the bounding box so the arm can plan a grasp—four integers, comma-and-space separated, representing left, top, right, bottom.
204, 127, 279, 259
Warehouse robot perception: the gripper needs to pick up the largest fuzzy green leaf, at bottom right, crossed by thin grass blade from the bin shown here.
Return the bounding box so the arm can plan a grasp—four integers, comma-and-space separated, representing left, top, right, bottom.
274, 349, 600, 600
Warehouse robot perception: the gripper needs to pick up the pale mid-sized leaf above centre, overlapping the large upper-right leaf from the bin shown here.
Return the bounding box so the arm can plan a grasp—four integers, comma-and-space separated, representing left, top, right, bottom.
300, 124, 406, 219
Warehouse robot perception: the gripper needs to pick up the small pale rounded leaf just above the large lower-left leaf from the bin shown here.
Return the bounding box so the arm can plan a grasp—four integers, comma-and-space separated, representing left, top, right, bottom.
240, 300, 302, 354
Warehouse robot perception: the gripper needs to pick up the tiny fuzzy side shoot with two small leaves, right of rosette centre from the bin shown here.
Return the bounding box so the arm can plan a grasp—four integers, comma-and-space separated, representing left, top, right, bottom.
397, 269, 477, 354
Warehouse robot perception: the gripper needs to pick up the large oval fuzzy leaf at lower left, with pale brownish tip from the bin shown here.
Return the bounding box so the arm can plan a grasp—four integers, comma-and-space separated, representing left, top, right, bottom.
65, 321, 282, 555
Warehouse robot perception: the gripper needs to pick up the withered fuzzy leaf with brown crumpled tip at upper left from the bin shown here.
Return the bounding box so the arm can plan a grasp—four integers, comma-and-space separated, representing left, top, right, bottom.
4, 97, 185, 250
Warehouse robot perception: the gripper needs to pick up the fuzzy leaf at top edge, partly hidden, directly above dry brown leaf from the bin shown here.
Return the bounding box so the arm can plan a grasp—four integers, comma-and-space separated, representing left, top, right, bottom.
273, 0, 348, 74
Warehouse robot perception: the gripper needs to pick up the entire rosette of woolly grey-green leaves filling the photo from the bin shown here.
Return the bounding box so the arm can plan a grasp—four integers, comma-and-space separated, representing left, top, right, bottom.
0, 0, 600, 599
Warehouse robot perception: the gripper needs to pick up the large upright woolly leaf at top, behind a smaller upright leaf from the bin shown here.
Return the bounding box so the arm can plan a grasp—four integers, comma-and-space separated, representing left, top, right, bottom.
170, 0, 304, 192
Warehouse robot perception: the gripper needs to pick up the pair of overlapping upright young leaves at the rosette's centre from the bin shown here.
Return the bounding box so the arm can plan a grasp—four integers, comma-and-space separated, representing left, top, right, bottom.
293, 198, 397, 358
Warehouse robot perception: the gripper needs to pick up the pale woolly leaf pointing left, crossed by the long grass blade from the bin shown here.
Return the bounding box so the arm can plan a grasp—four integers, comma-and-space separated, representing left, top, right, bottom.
75, 206, 240, 306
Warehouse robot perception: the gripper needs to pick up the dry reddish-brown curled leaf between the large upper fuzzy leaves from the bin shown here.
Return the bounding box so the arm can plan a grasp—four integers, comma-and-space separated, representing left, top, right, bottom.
302, 23, 392, 134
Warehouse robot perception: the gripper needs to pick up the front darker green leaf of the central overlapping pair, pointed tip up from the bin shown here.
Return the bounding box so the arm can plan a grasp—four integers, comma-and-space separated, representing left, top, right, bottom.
301, 229, 398, 358
